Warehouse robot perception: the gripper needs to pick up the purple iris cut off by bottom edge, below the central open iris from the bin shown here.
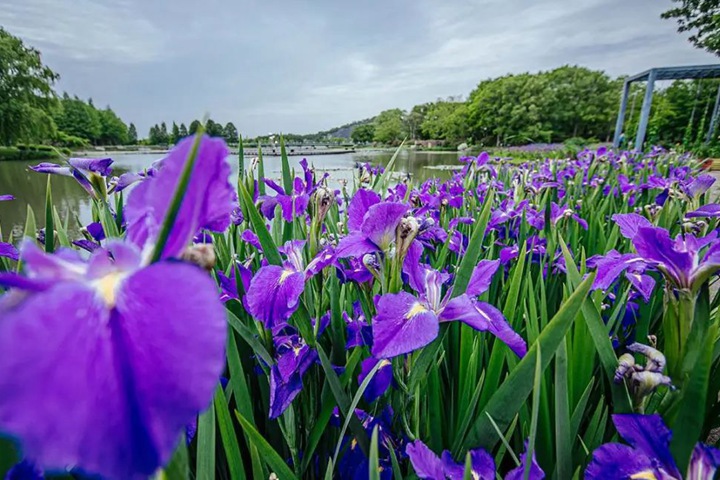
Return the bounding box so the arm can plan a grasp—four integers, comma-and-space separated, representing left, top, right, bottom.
405, 440, 545, 480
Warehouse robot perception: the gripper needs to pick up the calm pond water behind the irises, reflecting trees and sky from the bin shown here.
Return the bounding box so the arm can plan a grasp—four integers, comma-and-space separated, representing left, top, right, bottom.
0, 151, 458, 238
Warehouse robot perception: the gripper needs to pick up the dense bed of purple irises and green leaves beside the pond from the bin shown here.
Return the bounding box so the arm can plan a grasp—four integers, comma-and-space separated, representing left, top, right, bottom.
0, 135, 720, 480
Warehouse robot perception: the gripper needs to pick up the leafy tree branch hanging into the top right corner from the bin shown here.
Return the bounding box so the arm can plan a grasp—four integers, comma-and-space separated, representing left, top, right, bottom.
662, 0, 720, 55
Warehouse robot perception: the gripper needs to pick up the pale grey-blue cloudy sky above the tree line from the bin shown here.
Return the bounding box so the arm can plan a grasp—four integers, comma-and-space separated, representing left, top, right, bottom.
0, 0, 717, 136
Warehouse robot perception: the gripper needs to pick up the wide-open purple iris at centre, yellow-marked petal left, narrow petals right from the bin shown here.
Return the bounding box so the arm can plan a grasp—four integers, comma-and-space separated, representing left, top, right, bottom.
372, 260, 527, 358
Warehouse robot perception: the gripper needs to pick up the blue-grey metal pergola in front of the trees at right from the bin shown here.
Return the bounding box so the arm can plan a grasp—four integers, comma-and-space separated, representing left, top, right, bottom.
613, 64, 720, 149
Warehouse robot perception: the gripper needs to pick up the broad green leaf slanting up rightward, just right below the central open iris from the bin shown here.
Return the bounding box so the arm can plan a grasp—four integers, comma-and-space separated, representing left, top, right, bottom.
464, 274, 595, 450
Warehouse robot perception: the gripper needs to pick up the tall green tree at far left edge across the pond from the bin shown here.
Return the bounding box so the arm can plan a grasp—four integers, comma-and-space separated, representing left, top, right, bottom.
0, 27, 60, 145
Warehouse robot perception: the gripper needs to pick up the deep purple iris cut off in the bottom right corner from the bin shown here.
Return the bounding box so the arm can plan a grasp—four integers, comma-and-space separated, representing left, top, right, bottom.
585, 414, 720, 480
